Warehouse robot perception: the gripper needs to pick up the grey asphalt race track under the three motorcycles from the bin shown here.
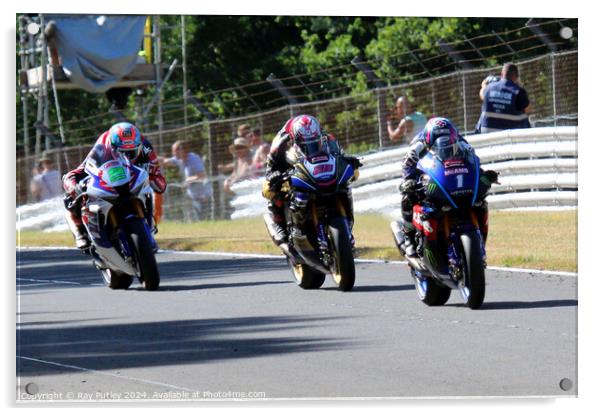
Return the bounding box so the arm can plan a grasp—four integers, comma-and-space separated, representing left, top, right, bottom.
16, 249, 577, 402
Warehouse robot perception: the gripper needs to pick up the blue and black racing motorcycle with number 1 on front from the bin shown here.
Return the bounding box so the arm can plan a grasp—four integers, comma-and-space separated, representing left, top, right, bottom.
391, 140, 488, 309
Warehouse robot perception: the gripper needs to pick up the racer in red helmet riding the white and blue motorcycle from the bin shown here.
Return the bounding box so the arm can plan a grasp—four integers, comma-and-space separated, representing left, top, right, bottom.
63, 122, 167, 250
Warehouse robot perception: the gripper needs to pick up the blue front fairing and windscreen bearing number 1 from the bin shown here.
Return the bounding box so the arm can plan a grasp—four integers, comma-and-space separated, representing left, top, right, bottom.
418, 143, 479, 208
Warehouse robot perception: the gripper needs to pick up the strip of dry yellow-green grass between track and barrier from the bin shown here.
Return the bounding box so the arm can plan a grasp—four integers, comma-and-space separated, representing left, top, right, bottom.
17, 211, 577, 272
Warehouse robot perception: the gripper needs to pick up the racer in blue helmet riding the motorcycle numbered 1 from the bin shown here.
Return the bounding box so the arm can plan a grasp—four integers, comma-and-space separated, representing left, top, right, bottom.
399, 117, 499, 257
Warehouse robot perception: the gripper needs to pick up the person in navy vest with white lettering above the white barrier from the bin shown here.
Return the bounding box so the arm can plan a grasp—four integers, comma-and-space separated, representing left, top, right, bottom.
475, 63, 532, 133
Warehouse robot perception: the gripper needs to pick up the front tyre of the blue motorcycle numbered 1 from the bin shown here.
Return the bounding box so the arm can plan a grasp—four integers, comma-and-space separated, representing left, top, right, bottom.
458, 231, 485, 309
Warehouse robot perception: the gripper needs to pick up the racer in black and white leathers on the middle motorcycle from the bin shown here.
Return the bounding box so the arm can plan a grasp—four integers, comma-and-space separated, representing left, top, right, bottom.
262, 115, 361, 250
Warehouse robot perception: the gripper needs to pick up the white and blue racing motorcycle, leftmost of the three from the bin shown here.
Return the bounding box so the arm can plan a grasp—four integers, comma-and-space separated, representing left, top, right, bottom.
71, 155, 160, 290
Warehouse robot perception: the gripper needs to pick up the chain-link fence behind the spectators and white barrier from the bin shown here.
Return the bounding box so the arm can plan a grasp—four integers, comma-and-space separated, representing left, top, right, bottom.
17, 51, 578, 220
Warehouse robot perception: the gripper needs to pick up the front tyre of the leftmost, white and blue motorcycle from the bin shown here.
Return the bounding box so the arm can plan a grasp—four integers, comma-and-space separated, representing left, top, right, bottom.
123, 218, 159, 290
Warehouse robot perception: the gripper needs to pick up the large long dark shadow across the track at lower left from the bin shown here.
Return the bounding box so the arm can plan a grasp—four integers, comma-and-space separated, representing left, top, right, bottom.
17, 315, 358, 376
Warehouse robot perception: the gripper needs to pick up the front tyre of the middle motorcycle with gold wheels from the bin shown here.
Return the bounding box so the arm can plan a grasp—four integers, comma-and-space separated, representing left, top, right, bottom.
328, 217, 355, 292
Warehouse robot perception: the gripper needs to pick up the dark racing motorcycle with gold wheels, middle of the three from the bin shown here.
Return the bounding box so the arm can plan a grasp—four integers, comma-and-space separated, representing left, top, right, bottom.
264, 148, 359, 291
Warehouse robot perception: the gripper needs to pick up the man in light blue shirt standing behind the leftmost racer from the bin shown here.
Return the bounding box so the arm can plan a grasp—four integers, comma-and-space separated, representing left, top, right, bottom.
162, 140, 213, 220
